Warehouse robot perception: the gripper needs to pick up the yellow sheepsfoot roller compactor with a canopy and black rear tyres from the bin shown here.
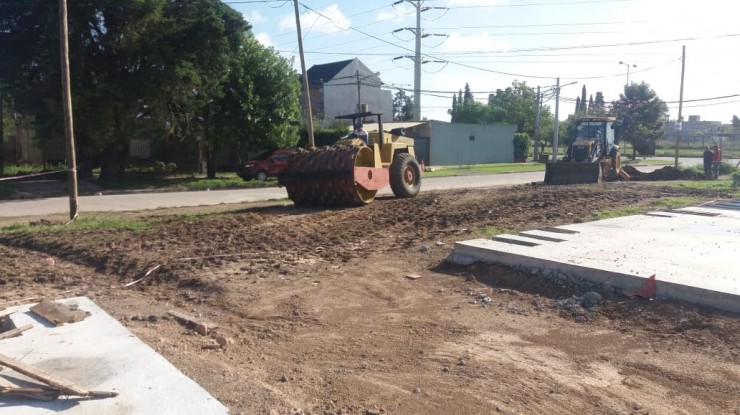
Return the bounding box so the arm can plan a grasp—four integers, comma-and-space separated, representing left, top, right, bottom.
278, 112, 421, 206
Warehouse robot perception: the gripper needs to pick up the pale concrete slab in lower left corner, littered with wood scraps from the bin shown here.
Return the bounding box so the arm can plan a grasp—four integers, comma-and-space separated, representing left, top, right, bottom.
0, 297, 228, 415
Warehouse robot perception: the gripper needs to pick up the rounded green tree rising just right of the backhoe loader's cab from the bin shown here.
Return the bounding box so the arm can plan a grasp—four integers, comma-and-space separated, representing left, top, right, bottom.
611, 82, 668, 154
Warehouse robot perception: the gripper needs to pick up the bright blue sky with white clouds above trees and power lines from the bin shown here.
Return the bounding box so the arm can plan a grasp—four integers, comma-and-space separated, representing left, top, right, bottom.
231, 0, 740, 123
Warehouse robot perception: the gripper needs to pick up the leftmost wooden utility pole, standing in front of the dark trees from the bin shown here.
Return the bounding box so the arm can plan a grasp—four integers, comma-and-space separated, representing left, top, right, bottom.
59, 0, 78, 221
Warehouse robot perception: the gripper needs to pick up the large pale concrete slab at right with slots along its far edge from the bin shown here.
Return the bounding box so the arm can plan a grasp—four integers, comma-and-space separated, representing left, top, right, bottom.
450, 200, 740, 313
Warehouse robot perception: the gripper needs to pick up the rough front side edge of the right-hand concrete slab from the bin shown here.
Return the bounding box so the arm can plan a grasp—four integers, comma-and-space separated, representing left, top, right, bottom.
447, 242, 740, 314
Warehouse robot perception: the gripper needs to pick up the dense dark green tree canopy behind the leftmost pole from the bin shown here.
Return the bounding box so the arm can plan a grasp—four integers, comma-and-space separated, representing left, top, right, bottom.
0, 0, 298, 178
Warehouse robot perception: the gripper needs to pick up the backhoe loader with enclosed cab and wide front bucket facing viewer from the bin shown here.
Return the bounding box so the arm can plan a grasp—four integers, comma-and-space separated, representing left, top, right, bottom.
545, 117, 629, 184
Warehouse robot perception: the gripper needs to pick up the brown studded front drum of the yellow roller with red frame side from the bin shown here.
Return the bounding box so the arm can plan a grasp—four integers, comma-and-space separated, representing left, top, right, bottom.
278, 146, 389, 206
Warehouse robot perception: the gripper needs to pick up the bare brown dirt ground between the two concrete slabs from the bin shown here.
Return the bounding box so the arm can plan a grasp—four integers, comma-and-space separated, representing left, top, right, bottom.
0, 183, 740, 415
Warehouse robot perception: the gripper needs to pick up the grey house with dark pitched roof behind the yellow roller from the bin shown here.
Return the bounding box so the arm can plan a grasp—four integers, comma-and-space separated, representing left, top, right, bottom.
301, 58, 393, 124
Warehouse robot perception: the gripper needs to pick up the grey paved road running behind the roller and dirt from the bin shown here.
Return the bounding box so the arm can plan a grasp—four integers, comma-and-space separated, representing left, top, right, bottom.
0, 159, 691, 217
